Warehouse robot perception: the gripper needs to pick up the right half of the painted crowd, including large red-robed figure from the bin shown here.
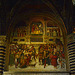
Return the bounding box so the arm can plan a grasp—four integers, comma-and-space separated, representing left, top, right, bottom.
39, 44, 65, 68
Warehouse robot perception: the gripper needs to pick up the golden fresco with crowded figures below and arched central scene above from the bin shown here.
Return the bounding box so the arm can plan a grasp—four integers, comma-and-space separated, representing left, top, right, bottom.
9, 22, 66, 72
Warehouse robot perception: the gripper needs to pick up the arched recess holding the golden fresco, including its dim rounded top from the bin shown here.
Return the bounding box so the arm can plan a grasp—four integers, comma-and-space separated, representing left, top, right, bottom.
4, 15, 69, 71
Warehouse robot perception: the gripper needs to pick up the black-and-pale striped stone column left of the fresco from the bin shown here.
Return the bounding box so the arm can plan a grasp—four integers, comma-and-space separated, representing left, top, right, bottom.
0, 36, 6, 75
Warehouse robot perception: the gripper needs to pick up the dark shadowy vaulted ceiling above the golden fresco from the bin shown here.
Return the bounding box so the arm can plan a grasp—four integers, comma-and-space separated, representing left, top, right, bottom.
0, 0, 72, 34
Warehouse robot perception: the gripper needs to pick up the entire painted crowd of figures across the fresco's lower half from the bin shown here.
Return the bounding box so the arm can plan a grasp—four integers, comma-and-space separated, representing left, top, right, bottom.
9, 44, 65, 68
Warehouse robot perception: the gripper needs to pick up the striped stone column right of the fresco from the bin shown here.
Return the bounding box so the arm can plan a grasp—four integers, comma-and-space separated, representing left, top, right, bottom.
67, 33, 75, 75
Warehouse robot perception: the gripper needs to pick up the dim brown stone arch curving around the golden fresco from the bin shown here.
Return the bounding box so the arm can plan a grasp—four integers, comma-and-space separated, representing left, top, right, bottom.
6, 0, 68, 70
